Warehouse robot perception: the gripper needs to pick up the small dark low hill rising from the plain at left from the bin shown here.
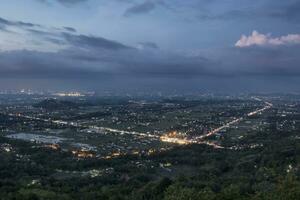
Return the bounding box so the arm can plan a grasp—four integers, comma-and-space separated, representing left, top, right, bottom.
33, 99, 79, 110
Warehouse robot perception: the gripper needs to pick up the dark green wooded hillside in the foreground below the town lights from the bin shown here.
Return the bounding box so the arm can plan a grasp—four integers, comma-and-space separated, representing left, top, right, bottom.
0, 125, 300, 200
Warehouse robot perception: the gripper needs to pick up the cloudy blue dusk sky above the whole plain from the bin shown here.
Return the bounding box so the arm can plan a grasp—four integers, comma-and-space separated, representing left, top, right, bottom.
0, 0, 300, 92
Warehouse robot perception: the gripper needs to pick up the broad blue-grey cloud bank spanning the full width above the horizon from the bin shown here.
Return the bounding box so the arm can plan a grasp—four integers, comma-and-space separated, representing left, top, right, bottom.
0, 15, 300, 79
